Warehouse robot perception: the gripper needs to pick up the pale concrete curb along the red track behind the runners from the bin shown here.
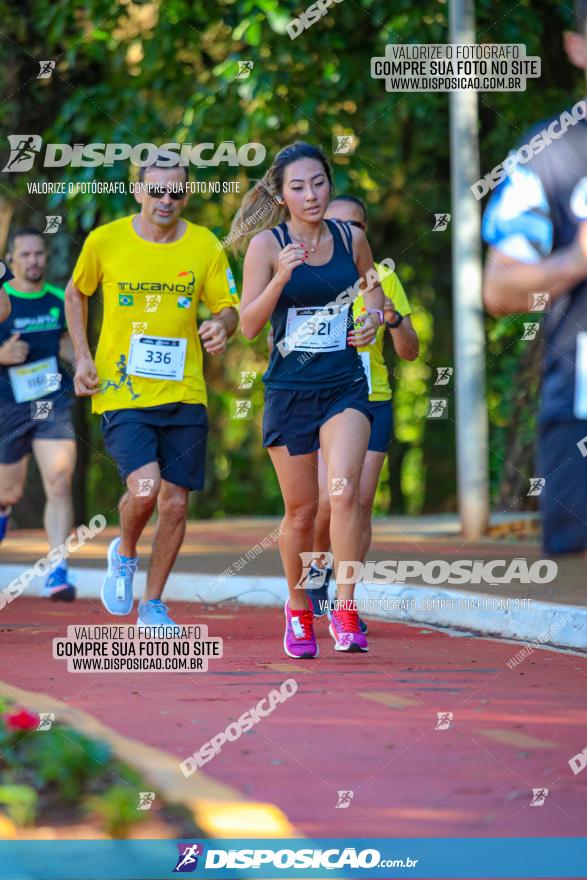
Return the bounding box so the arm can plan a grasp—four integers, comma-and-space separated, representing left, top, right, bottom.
0, 565, 587, 652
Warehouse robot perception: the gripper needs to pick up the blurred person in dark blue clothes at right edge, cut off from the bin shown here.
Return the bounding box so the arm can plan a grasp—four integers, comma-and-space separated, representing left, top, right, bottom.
483, 0, 587, 554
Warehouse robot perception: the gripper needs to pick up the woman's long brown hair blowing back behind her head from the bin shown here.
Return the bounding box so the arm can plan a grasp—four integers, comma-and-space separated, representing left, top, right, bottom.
228, 141, 332, 253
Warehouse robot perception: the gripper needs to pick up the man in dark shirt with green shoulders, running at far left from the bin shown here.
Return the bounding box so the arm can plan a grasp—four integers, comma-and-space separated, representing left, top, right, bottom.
0, 229, 76, 601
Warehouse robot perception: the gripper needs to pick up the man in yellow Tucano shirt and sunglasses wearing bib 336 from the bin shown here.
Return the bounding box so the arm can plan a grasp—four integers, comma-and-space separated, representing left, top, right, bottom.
66, 164, 238, 627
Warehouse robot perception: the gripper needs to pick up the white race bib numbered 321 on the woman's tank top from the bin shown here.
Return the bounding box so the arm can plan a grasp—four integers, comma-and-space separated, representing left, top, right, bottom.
284, 306, 349, 354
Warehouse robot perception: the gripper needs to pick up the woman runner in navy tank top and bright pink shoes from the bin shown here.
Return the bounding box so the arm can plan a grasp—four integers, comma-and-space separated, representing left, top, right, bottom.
231, 143, 383, 659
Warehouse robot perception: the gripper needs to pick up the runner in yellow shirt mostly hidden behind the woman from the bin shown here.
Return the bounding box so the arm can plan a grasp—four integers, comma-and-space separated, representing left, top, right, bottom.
307, 195, 418, 632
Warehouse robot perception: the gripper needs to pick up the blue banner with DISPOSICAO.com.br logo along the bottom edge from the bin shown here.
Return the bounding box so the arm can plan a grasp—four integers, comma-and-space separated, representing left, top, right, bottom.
0, 837, 587, 880
